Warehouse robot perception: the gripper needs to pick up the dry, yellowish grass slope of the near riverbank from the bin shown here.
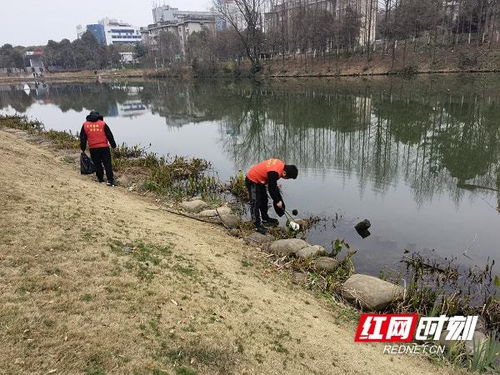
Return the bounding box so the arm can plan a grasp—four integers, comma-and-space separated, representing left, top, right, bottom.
0, 125, 464, 374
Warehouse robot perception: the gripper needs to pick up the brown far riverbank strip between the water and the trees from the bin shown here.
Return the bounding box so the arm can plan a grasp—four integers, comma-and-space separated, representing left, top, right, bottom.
0, 43, 500, 84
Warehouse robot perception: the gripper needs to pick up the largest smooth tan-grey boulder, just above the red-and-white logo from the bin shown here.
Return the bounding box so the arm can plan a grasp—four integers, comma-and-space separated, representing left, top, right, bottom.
342, 274, 404, 310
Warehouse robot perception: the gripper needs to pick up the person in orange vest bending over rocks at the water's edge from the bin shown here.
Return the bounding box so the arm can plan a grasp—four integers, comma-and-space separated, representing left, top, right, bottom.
245, 159, 298, 234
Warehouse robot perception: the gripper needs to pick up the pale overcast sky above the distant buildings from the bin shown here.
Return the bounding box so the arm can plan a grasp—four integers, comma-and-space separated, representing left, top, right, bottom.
0, 0, 211, 46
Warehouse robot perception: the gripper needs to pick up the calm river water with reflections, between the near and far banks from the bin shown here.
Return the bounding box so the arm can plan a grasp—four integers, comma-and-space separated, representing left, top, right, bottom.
0, 75, 500, 274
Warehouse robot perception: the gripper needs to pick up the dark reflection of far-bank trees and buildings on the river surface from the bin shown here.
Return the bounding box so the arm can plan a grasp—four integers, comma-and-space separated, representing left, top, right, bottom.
0, 76, 500, 209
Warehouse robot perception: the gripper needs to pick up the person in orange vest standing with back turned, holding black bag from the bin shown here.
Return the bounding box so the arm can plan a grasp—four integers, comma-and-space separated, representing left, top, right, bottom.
80, 111, 116, 186
